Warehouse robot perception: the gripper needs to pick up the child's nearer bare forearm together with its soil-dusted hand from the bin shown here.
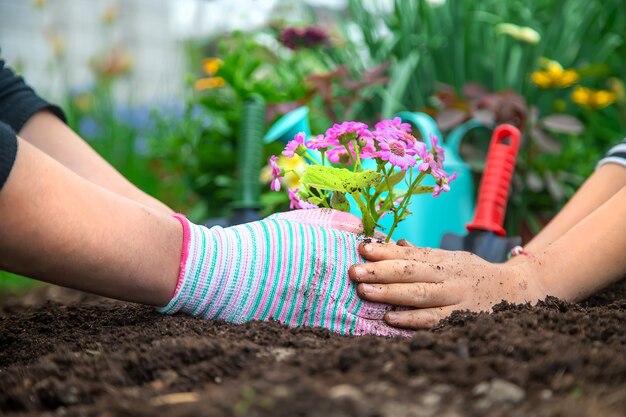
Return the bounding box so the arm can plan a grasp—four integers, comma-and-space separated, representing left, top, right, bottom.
350, 184, 626, 328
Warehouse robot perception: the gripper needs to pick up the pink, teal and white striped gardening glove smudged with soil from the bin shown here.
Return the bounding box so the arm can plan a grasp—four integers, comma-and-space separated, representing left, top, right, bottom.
159, 209, 412, 336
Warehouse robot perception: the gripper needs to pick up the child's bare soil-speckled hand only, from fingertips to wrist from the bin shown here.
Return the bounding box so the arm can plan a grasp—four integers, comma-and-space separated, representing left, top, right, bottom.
349, 241, 547, 329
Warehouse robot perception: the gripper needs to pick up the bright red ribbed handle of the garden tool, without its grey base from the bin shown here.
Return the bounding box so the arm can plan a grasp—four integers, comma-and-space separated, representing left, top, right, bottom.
467, 124, 520, 236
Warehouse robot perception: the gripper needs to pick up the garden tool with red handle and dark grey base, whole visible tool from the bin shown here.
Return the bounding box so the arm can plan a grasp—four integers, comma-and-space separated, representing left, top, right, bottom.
441, 124, 521, 262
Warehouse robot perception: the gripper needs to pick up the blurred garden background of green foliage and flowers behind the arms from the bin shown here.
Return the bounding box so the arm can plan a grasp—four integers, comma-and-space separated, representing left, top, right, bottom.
0, 0, 626, 285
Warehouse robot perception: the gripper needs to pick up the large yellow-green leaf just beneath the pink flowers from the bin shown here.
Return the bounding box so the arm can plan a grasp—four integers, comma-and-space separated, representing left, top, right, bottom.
302, 165, 383, 194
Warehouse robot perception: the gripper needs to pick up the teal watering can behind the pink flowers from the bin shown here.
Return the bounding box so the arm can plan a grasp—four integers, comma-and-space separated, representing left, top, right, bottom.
264, 106, 485, 247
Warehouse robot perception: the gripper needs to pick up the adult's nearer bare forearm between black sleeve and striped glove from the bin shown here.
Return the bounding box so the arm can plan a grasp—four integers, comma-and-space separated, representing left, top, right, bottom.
0, 134, 182, 305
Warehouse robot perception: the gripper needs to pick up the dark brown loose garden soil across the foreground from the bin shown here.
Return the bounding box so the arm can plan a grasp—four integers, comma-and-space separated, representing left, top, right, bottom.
0, 281, 626, 417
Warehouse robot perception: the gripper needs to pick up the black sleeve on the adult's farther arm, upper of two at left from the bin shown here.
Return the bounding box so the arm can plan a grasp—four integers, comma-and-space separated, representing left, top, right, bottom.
0, 59, 66, 133
